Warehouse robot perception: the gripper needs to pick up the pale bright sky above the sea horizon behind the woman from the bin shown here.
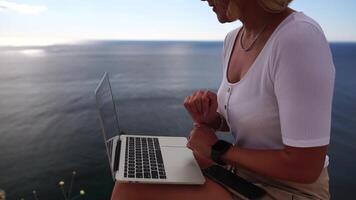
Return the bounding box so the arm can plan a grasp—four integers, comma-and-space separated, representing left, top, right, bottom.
0, 0, 356, 46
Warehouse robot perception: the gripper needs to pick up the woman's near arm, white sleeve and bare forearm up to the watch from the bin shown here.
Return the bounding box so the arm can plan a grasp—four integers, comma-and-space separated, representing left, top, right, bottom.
218, 22, 335, 183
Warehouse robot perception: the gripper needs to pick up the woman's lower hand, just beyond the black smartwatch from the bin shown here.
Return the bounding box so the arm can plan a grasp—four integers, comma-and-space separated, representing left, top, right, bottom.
187, 126, 218, 162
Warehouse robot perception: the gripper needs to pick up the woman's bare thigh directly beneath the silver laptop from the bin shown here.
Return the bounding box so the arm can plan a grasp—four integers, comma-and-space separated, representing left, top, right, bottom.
111, 178, 232, 200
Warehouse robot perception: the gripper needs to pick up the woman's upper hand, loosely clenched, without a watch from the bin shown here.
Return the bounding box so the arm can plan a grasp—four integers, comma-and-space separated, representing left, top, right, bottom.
184, 91, 219, 125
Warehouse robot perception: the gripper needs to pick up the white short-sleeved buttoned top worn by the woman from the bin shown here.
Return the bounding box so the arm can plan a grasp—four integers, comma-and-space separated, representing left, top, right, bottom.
218, 12, 335, 166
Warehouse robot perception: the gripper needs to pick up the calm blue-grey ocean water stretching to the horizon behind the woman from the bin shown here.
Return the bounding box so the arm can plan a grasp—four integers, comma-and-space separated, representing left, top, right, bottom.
0, 41, 356, 199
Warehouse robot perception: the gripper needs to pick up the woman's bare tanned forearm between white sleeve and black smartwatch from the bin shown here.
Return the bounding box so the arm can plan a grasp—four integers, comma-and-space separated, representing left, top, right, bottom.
222, 146, 328, 183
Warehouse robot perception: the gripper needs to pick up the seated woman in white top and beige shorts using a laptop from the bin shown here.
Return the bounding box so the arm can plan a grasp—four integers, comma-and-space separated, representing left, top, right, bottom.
112, 0, 335, 200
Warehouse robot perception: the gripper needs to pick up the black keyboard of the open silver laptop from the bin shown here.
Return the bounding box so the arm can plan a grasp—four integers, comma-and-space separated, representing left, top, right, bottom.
124, 137, 166, 179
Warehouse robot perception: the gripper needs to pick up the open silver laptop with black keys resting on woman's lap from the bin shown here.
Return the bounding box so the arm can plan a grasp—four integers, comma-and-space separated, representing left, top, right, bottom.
95, 73, 205, 184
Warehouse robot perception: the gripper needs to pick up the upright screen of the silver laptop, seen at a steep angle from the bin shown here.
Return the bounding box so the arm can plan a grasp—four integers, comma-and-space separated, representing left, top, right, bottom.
95, 72, 119, 167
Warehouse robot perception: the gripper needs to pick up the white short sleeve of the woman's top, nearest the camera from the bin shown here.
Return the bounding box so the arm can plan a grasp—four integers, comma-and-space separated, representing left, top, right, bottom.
272, 22, 335, 147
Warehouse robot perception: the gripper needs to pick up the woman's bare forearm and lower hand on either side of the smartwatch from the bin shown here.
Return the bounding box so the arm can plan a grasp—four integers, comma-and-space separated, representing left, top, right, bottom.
187, 126, 328, 183
